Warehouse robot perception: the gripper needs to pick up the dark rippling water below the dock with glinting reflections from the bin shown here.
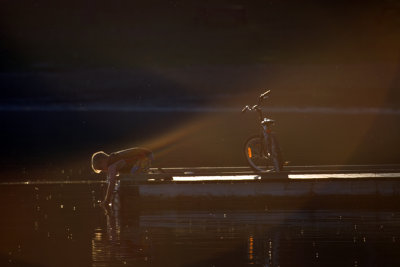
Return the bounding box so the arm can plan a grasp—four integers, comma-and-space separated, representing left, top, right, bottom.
0, 183, 400, 266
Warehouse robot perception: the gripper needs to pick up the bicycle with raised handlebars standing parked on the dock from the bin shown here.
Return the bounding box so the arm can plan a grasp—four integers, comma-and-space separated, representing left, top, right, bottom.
242, 90, 283, 172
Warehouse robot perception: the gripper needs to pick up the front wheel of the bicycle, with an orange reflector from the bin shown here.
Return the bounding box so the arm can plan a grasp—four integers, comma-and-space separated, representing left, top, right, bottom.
244, 135, 271, 172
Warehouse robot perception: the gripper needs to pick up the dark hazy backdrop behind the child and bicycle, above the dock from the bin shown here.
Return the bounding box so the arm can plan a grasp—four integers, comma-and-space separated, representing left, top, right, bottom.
0, 0, 400, 180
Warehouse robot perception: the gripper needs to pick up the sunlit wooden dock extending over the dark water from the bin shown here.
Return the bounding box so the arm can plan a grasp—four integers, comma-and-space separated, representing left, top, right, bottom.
117, 165, 400, 204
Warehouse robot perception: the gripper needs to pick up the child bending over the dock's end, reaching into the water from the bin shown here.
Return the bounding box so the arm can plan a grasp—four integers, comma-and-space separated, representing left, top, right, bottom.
92, 147, 153, 205
